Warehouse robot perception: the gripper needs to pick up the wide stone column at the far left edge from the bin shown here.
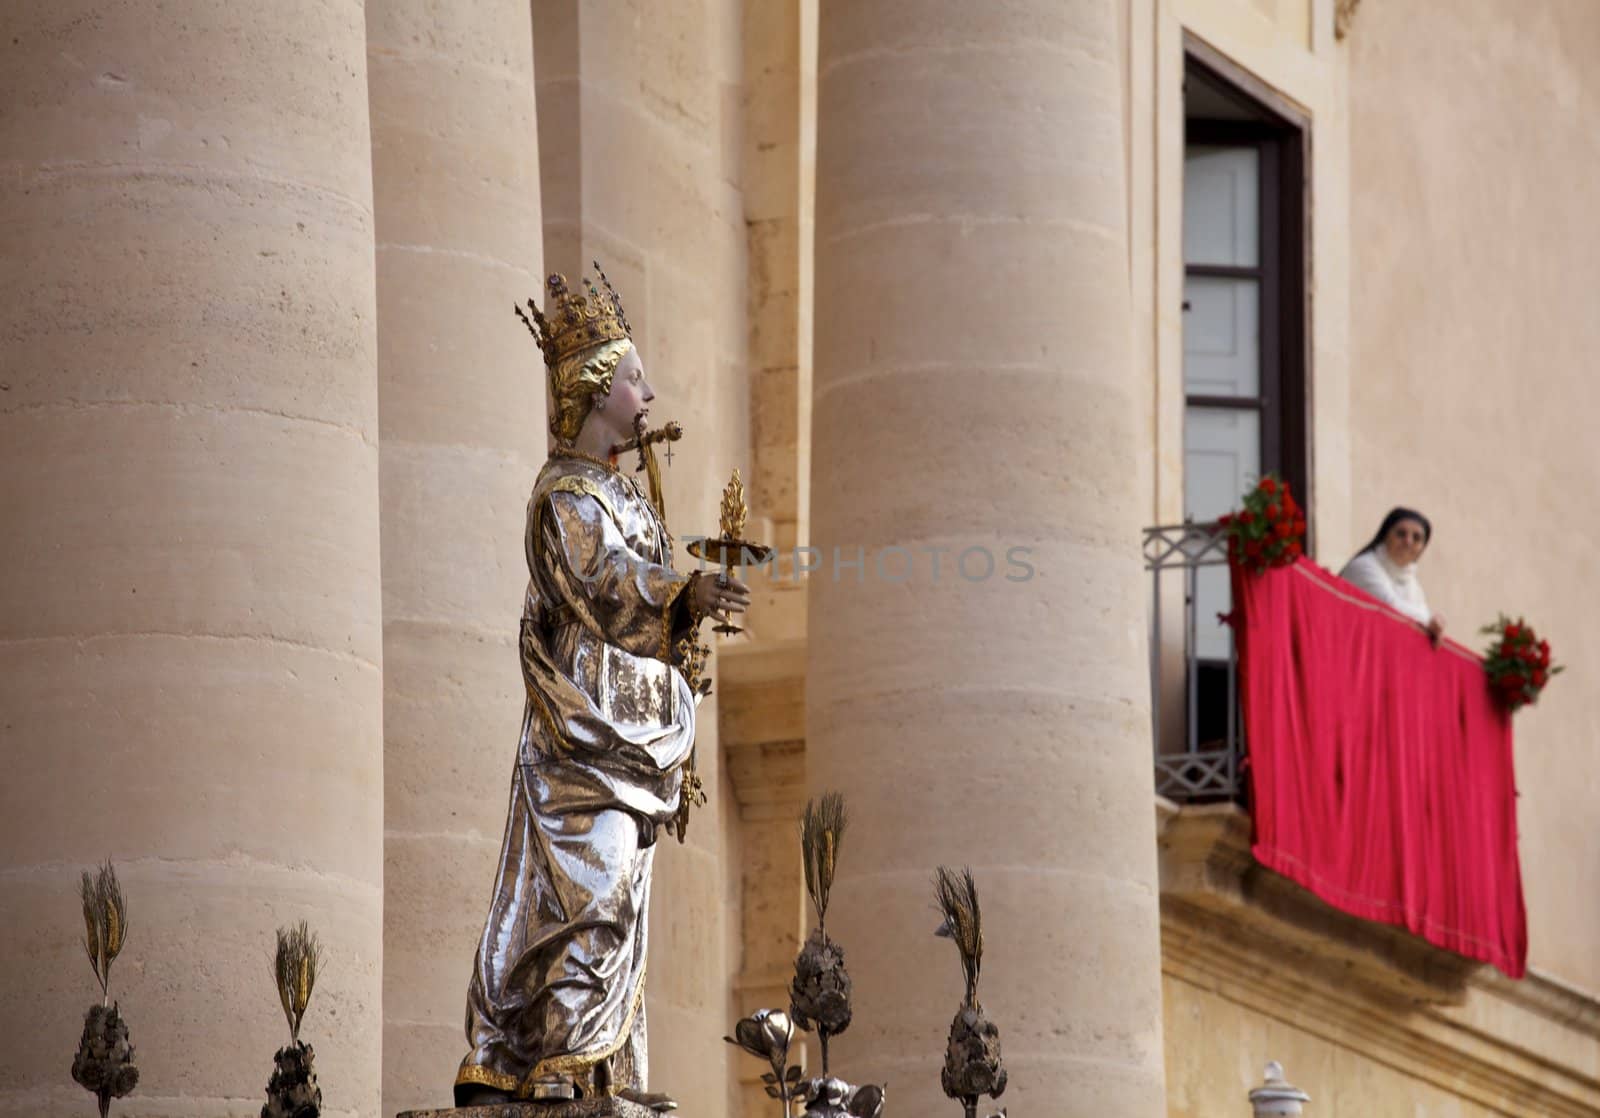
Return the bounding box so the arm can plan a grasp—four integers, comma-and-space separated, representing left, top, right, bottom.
0, 0, 382, 1118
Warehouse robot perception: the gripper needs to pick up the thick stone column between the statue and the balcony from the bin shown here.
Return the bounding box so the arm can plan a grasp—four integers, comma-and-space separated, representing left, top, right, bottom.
806, 0, 1165, 1118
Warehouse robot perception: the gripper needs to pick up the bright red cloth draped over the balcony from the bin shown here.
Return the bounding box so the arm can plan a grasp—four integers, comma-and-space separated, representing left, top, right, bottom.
1234, 560, 1528, 979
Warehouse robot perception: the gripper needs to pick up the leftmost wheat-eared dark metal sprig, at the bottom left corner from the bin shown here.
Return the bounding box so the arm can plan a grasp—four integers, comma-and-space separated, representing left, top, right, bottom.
72, 860, 139, 1118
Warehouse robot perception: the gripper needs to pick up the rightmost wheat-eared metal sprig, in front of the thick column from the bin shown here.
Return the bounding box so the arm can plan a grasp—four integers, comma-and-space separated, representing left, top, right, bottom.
933, 865, 1006, 1118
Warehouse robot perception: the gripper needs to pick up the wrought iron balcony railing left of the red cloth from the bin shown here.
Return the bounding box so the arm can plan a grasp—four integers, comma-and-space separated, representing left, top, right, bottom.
1144, 523, 1245, 803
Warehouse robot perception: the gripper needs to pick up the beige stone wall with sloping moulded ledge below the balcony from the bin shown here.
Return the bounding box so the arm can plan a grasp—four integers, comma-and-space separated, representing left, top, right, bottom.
1162, 959, 1600, 1118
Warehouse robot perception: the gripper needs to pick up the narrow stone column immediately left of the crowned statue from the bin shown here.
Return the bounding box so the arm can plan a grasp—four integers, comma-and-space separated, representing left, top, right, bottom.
366, 0, 546, 1113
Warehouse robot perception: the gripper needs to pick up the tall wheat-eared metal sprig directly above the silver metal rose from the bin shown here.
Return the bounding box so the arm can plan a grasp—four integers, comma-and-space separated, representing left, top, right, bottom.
789, 792, 851, 1078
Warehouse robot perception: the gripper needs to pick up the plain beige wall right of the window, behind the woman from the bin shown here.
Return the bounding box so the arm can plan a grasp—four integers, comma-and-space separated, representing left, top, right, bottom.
1350, 0, 1600, 990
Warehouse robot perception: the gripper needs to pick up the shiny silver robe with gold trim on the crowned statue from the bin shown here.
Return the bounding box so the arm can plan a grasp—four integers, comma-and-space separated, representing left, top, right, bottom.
456, 451, 694, 1096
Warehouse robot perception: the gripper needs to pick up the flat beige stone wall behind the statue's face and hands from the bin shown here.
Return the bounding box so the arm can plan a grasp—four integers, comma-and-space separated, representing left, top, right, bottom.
533, 0, 750, 1118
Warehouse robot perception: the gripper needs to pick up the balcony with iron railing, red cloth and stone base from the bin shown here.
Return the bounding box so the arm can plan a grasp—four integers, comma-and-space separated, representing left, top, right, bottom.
1144, 525, 1526, 1003
